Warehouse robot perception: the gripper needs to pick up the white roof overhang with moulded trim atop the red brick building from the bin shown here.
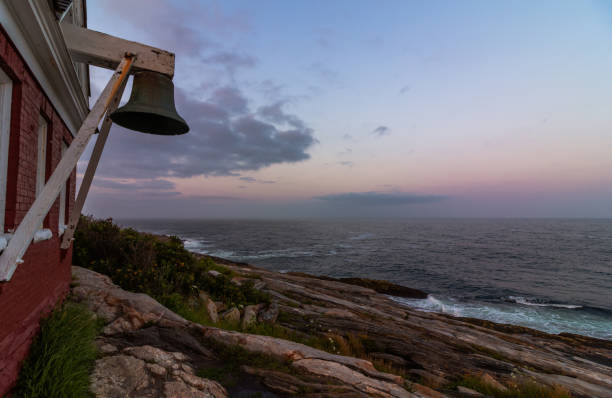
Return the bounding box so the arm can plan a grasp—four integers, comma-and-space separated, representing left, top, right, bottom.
0, 0, 89, 135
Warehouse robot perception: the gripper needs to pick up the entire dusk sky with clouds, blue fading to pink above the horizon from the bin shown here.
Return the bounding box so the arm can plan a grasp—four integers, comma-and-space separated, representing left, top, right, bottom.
79, 0, 612, 218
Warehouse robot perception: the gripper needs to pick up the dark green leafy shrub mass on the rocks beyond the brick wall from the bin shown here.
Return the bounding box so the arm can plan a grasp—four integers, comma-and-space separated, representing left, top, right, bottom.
73, 216, 269, 312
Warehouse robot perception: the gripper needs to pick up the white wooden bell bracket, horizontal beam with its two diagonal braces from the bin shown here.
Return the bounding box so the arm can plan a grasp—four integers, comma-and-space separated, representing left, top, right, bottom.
0, 19, 183, 282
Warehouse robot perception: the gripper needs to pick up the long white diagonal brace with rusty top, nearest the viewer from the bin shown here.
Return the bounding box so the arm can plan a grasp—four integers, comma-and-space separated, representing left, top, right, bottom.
0, 55, 134, 281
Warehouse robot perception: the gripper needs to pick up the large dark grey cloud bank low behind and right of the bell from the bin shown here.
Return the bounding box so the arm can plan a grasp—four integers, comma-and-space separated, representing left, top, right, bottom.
99, 87, 317, 179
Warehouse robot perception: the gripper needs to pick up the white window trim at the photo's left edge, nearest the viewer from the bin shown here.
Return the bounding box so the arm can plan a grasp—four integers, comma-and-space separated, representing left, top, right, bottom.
0, 70, 13, 234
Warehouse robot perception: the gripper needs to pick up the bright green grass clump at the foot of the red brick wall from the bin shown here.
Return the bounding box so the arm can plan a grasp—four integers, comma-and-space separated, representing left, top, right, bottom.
13, 303, 101, 398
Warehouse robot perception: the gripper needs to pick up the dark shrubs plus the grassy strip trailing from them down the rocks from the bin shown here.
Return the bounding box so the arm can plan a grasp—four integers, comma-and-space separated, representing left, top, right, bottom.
73, 216, 406, 360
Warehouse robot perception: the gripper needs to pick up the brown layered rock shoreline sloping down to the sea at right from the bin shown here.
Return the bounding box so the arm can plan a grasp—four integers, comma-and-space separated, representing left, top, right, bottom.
72, 258, 612, 398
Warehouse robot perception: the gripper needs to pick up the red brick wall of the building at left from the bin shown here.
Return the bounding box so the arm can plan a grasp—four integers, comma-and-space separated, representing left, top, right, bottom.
0, 26, 76, 396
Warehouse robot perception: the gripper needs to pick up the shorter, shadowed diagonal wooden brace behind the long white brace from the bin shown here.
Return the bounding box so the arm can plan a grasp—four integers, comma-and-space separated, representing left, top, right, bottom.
61, 70, 127, 249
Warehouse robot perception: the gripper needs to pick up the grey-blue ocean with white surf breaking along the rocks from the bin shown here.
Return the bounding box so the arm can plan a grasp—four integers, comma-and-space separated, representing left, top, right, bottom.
117, 219, 612, 340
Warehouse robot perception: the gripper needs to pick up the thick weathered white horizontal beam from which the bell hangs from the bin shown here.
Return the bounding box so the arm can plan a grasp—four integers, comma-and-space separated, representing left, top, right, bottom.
61, 23, 174, 77
